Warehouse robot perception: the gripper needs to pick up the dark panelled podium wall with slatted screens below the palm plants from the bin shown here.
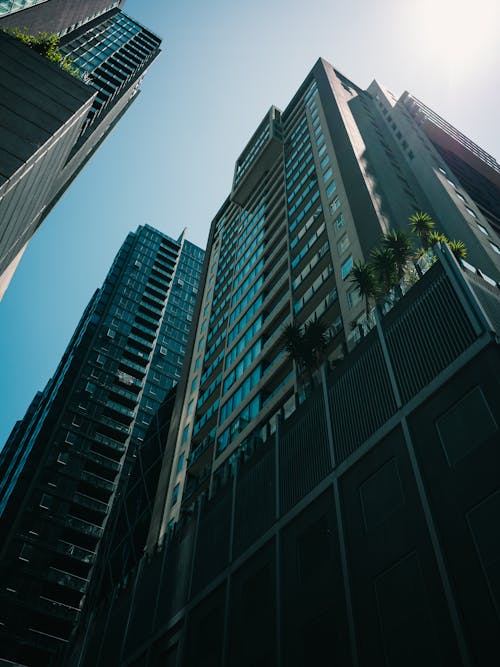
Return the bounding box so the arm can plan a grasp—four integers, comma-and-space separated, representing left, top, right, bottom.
74, 250, 500, 667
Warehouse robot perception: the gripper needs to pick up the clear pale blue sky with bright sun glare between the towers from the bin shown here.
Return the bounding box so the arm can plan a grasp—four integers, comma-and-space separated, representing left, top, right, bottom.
0, 0, 500, 448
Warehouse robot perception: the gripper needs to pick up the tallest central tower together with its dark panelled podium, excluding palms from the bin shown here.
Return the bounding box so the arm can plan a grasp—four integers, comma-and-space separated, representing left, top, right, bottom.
66, 60, 500, 667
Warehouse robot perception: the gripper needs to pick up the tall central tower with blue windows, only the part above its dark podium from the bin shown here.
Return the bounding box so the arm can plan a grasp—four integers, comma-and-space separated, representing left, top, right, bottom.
150, 60, 500, 548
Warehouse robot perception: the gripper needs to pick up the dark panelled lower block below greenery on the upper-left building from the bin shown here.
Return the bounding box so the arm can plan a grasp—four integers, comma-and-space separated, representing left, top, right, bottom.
0, 33, 96, 288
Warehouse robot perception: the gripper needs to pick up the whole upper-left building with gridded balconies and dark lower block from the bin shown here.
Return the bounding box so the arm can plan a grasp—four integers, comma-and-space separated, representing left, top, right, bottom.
0, 0, 160, 297
